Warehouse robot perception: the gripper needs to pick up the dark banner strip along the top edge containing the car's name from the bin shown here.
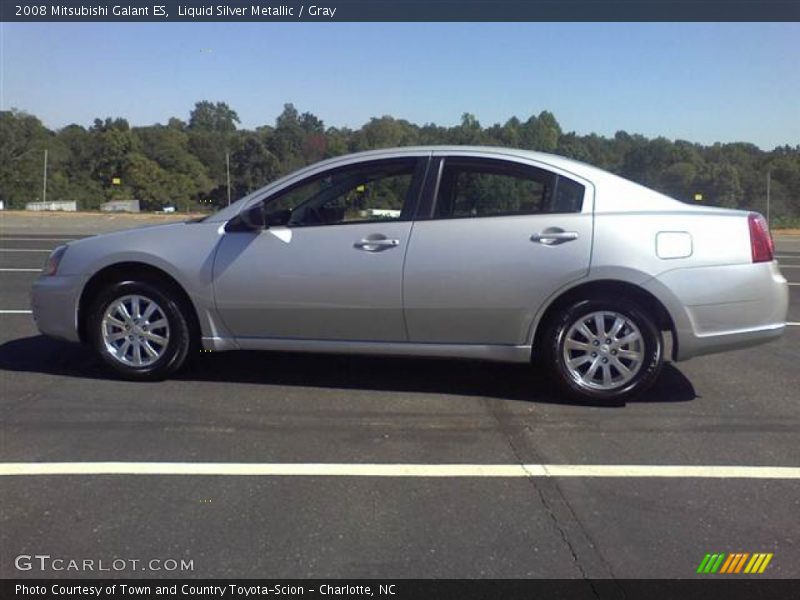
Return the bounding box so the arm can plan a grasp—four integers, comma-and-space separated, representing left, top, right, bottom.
0, 0, 800, 23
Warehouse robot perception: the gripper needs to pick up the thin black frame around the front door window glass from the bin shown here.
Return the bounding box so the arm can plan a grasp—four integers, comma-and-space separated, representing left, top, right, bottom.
260, 155, 431, 229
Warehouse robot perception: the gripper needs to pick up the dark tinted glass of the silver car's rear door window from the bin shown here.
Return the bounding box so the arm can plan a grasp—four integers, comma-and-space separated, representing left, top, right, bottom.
434, 159, 583, 219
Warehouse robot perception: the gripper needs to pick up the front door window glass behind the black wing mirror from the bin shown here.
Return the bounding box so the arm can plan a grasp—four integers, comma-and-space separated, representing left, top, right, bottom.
265, 159, 417, 227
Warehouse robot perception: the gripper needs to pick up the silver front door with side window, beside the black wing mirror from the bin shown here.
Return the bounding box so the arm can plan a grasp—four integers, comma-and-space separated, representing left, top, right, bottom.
213, 157, 427, 342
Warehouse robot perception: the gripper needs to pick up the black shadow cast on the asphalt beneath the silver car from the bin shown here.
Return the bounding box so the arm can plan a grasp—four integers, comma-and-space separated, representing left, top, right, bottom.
0, 335, 696, 407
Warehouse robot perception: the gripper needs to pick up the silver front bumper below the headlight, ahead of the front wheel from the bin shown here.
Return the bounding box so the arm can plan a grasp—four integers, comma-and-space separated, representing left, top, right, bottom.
31, 275, 86, 342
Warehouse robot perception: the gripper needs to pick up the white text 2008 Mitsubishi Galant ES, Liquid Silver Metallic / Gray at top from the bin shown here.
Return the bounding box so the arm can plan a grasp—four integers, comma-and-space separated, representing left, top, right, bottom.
26, 4, 337, 19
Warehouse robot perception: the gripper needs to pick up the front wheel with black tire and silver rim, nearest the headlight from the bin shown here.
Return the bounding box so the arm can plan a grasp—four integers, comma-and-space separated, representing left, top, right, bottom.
88, 281, 191, 381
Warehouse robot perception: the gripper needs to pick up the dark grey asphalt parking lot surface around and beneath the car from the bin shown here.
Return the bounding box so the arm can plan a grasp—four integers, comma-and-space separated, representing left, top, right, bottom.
0, 227, 800, 578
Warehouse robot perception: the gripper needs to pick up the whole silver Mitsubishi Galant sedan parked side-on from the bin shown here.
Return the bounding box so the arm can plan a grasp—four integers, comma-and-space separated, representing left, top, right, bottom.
32, 147, 788, 401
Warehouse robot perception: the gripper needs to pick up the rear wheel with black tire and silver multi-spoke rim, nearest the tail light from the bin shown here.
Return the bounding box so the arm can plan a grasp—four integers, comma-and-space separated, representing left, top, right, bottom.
543, 298, 664, 404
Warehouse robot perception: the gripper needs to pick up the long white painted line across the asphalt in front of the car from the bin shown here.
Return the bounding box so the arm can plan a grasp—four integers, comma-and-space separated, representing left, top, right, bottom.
0, 462, 800, 479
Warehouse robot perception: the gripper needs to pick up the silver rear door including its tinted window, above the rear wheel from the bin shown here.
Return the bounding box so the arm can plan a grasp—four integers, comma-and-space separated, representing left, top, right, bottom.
403, 155, 593, 345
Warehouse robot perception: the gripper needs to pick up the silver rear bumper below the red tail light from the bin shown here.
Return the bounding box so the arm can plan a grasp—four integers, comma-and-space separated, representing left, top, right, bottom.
645, 262, 789, 360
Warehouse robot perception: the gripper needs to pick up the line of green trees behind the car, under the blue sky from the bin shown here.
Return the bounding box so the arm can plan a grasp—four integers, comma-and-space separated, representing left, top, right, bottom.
0, 101, 800, 223
